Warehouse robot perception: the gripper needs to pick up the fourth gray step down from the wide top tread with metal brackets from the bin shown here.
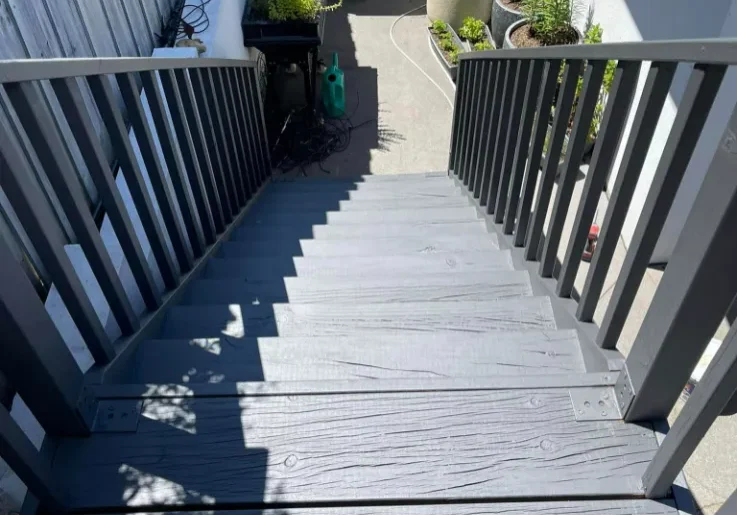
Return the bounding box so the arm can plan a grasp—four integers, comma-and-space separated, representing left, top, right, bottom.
205, 250, 514, 281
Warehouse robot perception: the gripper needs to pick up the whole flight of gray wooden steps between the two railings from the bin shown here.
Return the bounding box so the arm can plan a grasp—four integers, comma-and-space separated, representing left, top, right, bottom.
44, 172, 675, 514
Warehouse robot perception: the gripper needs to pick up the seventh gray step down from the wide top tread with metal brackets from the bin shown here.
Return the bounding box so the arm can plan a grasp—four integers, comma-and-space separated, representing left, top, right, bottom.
243, 204, 478, 227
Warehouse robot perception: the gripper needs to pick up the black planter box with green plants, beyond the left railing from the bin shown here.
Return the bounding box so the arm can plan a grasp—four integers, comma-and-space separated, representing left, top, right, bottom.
241, 0, 343, 48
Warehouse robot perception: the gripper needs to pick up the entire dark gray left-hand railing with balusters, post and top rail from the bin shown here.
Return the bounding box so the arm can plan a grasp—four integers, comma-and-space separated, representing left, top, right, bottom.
0, 58, 271, 512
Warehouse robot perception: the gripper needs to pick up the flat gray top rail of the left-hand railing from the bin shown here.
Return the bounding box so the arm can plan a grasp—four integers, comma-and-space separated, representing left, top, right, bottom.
0, 57, 256, 84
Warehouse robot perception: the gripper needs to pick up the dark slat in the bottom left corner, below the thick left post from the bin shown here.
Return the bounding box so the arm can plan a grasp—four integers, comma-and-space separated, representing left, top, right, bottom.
0, 406, 67, 513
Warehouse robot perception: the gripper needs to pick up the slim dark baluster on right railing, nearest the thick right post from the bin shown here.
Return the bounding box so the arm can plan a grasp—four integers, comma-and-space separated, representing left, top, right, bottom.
597, 64, 724, 348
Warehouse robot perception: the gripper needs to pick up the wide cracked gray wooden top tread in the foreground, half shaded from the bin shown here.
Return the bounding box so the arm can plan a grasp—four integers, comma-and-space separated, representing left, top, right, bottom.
53, 381, 657, 513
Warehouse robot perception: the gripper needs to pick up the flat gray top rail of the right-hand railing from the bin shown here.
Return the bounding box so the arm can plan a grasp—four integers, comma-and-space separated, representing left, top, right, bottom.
458, 38, 737, 65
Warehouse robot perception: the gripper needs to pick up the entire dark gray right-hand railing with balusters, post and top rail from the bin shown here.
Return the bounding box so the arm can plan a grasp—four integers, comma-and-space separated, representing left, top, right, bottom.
448, 39, 737, 502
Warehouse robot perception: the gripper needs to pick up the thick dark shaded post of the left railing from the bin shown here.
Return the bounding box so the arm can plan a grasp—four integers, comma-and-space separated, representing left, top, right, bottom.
0, 238, 90, 436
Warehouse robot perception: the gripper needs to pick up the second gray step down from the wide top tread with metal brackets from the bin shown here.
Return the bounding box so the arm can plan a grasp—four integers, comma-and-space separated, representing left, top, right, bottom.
161, 297, 556, 339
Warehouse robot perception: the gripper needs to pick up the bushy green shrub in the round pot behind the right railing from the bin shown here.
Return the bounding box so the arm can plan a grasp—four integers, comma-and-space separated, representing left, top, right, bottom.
522, 0, 578, 46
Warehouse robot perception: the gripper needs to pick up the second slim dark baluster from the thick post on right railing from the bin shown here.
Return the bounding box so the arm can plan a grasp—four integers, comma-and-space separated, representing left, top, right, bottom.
574, 62, 676, 322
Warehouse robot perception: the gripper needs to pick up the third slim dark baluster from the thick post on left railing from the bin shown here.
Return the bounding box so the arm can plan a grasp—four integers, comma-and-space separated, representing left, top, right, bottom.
51, 78, 161, 311
